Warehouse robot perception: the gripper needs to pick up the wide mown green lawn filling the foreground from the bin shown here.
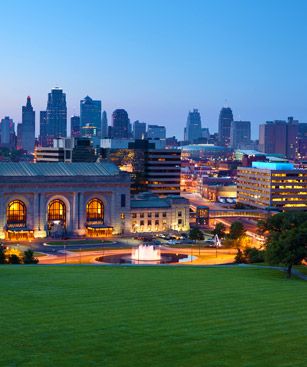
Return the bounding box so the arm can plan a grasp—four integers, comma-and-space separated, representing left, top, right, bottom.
0, 266, 307, 367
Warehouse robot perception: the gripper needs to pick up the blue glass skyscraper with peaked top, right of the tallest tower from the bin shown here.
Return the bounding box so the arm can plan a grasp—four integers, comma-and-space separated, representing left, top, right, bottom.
80, 96, 101, 138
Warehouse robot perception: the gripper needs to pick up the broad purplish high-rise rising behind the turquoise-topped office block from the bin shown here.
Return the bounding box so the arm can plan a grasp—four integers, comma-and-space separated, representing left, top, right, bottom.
259, 118, 299, 159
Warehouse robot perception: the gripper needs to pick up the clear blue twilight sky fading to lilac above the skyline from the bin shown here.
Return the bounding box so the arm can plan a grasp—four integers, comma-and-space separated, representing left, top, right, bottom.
0, 0, 307, 138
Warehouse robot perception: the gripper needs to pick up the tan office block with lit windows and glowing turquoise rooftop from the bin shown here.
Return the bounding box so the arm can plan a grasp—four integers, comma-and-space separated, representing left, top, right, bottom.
237, 162, 307, 211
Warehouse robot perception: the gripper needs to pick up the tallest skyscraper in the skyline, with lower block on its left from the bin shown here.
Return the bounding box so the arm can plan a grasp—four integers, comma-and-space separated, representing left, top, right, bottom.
40, 87, 67, 146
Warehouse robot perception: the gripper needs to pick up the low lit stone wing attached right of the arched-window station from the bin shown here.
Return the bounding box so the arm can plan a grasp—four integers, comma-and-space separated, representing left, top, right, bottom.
131, 193, 190, 233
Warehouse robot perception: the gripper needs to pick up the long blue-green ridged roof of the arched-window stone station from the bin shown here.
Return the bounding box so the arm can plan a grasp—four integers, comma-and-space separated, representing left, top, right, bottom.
0, 162, 120, 177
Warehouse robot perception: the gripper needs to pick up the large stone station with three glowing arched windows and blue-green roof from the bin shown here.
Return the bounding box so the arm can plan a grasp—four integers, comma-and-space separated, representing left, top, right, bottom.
0, 162, 130, 240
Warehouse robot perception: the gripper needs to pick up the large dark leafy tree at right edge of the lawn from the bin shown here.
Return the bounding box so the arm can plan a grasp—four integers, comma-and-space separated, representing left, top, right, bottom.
261, 212, 307, 278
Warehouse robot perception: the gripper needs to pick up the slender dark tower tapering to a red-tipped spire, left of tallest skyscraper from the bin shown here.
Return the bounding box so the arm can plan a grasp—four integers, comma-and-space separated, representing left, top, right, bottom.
21, 97, 35, 153
